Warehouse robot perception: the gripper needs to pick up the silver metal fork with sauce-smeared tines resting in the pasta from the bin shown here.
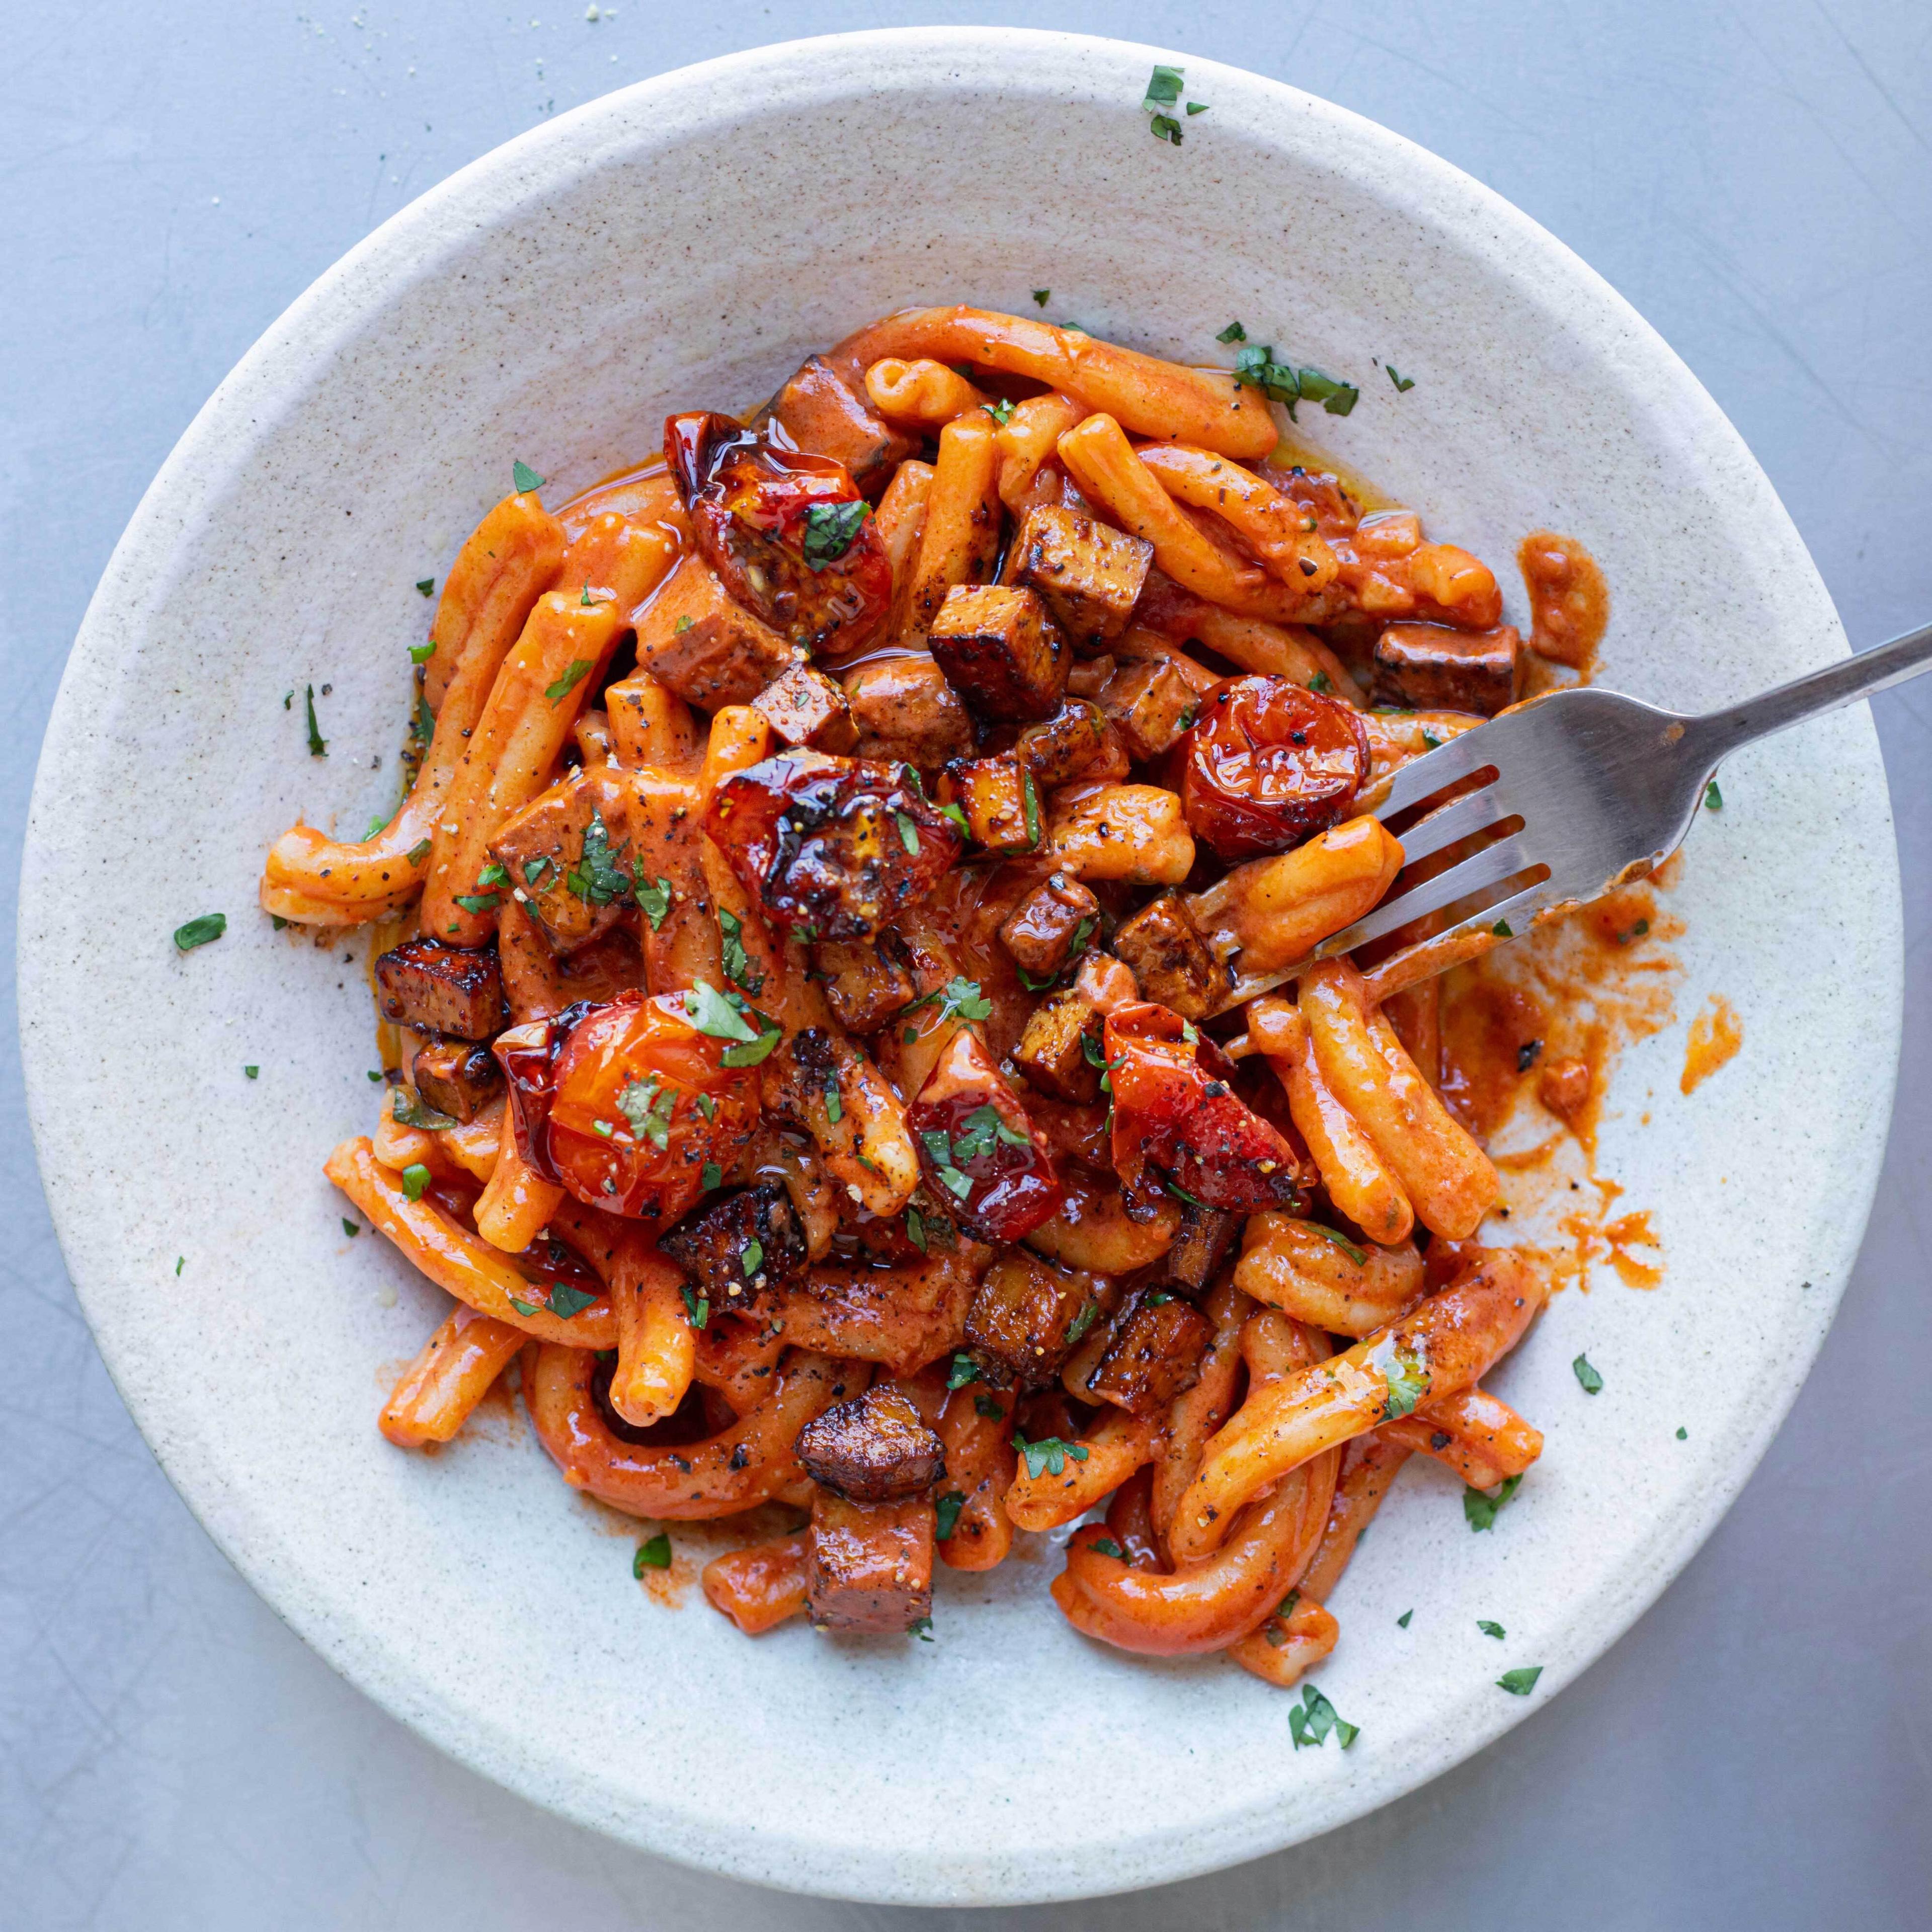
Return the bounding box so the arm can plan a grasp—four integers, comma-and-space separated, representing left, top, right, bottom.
1298, 624, 1932, 997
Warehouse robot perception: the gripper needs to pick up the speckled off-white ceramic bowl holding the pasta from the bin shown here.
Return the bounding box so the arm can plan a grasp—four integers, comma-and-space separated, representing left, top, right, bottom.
19, 29, 1901, 1901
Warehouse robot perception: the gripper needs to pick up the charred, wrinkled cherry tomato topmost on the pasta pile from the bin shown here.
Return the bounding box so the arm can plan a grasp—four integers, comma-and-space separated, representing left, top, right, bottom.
665, 410, 893, 657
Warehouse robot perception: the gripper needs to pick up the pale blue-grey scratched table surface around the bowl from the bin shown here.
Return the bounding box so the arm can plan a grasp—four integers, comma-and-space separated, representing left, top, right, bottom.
0, 0, 1932, 1932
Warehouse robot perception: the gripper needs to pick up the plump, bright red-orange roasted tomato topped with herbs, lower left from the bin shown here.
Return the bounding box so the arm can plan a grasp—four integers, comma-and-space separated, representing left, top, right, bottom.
497, 993, 757, 1225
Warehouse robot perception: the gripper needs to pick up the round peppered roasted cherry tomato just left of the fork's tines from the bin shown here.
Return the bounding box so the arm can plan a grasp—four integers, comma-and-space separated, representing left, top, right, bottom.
1180, 676, 1368, 863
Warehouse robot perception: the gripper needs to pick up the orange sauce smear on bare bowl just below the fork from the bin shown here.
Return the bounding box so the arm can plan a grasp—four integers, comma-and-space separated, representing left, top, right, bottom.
1441, 867, 1683, 1289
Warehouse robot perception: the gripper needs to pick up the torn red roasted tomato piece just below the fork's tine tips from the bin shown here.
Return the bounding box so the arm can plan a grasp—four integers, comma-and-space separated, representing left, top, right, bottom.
1105, 1003, 1302, 1214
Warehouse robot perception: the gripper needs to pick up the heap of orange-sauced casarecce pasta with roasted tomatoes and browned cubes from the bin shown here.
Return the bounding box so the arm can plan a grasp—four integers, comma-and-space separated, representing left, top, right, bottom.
261, 307, 1615, 1684
